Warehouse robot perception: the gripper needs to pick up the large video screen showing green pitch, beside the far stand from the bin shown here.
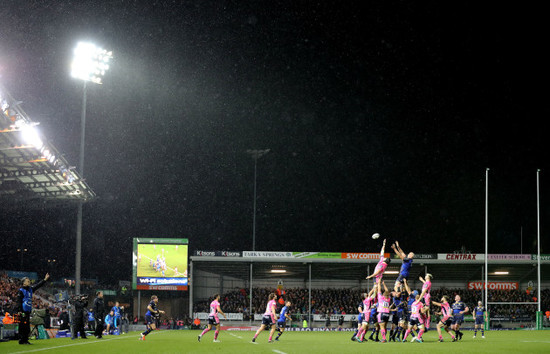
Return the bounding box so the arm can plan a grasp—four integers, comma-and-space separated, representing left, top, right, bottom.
132, 238, 188, 290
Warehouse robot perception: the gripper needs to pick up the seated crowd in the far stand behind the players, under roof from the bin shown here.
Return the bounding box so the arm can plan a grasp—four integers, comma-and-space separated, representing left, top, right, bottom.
194, 288, 550, 319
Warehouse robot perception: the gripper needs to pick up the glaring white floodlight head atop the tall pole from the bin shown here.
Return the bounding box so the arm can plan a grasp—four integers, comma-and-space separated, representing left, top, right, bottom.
71, 42, 113, 84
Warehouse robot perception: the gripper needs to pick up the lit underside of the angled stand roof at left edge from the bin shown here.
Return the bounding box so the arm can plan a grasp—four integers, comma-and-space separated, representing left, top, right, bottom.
0, 84, 95, 208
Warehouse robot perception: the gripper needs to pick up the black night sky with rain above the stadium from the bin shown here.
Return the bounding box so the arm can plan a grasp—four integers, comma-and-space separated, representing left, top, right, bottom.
0, 0, 550, 281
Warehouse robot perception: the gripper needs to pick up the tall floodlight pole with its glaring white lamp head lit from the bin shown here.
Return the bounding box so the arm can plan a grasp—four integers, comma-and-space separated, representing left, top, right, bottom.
71, 42, 113, 294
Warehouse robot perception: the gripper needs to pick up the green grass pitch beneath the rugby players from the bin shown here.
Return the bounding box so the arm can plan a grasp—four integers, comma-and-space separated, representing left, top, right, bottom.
0, 330, 550, 354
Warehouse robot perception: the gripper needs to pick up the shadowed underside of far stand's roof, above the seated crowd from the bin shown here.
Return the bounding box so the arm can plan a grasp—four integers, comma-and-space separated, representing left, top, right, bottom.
191, 256, 550, 285
